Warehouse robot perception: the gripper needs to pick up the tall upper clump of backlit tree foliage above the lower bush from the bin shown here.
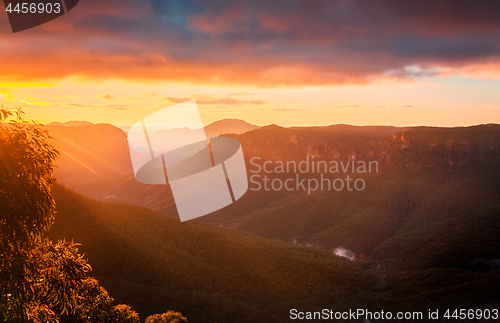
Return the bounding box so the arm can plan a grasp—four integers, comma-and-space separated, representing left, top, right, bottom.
0, 109, 59, 250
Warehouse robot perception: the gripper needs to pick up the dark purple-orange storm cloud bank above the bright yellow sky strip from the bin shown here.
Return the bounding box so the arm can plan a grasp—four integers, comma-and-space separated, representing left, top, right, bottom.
0, 0, 500, 86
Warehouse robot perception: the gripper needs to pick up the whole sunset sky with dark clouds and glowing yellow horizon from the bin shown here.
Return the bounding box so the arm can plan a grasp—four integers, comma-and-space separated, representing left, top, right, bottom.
0, 0, 500, 126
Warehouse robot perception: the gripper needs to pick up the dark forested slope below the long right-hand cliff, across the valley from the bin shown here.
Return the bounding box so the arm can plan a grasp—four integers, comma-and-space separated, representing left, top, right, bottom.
212, 165, 500, 269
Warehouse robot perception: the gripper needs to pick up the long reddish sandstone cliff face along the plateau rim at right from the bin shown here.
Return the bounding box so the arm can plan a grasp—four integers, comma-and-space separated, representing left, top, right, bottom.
229, 124, 500, 170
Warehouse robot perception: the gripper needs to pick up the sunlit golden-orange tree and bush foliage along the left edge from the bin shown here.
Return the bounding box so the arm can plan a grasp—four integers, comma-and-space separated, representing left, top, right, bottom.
0, 108, 143, 323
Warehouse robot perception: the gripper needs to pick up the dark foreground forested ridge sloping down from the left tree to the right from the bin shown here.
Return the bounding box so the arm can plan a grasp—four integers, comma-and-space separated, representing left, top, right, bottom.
49, 185, 500, 323
